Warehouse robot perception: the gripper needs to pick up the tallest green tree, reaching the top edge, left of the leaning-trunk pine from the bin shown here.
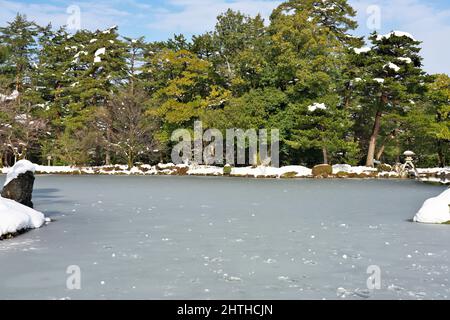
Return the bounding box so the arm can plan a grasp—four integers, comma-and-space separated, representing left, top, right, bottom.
267, 1, 356, 163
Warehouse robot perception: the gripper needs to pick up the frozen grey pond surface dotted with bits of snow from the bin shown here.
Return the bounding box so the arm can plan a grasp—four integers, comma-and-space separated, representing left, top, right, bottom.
0, 176, 450, 299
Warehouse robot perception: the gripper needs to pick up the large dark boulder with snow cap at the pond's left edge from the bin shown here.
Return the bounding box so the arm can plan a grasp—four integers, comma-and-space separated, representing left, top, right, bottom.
1, 171, 34, 208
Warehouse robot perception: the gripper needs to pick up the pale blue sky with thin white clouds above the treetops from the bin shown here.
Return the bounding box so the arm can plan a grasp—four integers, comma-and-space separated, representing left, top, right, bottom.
0, 0, 450, 74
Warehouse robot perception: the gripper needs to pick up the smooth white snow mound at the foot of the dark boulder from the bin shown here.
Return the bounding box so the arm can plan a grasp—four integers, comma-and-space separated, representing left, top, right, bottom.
0, 197, 47, 237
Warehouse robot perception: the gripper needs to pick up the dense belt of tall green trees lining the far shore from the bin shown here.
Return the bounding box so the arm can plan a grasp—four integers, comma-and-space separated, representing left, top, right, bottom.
0, 0, 444, 167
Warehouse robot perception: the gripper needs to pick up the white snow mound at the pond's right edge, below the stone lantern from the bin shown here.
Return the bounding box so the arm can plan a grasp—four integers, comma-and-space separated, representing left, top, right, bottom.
413, 189, 450, 223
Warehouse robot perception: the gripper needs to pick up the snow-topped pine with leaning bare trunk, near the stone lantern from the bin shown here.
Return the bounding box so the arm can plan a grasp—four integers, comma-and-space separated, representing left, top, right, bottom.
353, 31, 425, 166
